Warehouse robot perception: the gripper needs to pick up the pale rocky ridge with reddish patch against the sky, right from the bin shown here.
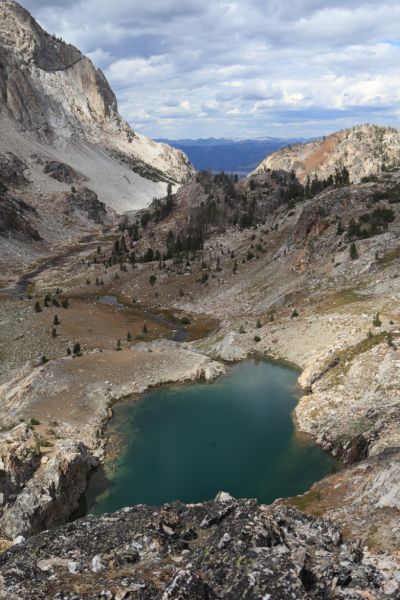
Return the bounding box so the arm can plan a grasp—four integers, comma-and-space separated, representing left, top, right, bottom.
255, 125, 400, 183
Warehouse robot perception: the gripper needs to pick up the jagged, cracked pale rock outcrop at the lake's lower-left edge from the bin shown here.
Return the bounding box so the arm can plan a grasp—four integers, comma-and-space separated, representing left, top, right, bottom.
0, 425, 97, 539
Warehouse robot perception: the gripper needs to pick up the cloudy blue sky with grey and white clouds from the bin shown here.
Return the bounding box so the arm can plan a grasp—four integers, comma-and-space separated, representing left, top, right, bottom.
22, 0, 400, 138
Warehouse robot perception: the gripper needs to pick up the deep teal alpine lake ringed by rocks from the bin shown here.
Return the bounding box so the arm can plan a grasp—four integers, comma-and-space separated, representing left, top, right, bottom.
87, 360, 336, 514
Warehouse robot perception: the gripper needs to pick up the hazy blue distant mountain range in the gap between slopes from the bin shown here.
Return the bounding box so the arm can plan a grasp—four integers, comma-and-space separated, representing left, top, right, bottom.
157, 137, 307, 176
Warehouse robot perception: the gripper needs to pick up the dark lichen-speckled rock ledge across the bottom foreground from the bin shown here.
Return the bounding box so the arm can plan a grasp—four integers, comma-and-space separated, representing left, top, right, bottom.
0, 493, 398, 600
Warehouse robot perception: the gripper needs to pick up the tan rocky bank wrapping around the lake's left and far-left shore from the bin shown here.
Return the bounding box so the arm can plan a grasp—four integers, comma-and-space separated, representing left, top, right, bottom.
0, 340, 225, 539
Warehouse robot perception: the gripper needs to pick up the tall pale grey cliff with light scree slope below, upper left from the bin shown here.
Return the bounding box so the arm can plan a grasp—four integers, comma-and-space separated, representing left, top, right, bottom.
0, 0, 191, 211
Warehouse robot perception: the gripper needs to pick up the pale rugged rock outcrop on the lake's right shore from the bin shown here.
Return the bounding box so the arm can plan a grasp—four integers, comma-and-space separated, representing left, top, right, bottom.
295, 332, 400, 463
